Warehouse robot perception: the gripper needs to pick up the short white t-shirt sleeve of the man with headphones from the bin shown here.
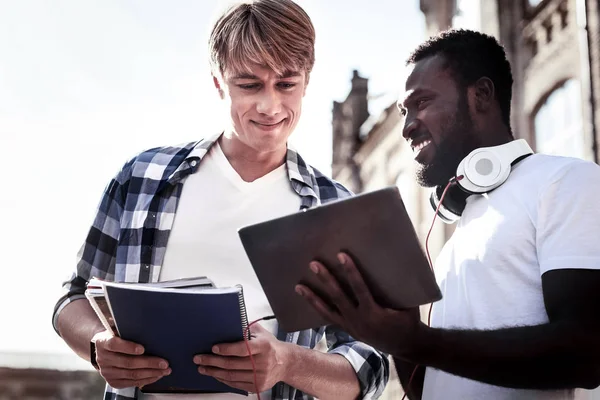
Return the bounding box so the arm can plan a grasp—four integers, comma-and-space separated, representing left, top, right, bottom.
536, 161, 600, 274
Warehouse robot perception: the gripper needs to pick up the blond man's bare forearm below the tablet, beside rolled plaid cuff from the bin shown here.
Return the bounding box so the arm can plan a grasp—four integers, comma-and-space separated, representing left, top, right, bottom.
284, 343, 360, 400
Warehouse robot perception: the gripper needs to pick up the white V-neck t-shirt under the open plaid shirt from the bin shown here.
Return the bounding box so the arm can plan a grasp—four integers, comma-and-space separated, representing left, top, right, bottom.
142, 143, 301, 400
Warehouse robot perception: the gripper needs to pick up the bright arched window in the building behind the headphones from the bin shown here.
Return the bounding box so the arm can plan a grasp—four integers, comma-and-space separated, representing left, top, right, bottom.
534, 79, 584, 158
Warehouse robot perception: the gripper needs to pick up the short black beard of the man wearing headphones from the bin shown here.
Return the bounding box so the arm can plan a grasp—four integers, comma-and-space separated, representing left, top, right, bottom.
416, 96, 474, 187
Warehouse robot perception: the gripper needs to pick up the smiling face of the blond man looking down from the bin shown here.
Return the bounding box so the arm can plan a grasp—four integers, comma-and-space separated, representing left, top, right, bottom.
215, 64, 306, 154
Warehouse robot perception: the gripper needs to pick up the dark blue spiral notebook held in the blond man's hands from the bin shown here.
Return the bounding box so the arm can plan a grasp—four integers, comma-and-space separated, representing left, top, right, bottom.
104, 282, 248, 395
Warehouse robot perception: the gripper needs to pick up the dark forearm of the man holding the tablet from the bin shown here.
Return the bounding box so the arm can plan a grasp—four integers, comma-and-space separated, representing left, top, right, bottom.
402, 322, 600, 389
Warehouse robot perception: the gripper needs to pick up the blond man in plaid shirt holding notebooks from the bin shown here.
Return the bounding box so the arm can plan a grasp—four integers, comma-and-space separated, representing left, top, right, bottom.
53, 0, 389, 400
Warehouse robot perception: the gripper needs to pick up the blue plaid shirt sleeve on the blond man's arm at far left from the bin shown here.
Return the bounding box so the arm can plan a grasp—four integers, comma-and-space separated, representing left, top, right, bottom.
52, 160, 133, 333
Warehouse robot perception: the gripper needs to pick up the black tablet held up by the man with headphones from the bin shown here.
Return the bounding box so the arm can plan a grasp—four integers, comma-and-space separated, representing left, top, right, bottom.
238, 186, 442, 332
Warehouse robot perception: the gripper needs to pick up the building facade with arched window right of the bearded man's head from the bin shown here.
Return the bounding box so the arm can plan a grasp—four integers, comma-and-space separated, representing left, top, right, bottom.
492, 0, 600, 162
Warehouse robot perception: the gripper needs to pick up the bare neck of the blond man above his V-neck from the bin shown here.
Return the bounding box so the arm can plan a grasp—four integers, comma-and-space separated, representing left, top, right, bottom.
219, 133, 287, 182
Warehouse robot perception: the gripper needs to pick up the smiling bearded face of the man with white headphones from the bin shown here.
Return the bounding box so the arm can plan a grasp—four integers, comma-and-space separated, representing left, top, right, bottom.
398, 55, 477, 187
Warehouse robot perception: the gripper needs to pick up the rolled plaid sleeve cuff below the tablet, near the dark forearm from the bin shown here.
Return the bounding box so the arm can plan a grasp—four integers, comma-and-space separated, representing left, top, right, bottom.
325, 326, 390, 399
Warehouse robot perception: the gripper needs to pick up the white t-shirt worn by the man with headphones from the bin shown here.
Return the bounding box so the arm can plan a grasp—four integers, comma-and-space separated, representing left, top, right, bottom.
423, 154, 600, 400
